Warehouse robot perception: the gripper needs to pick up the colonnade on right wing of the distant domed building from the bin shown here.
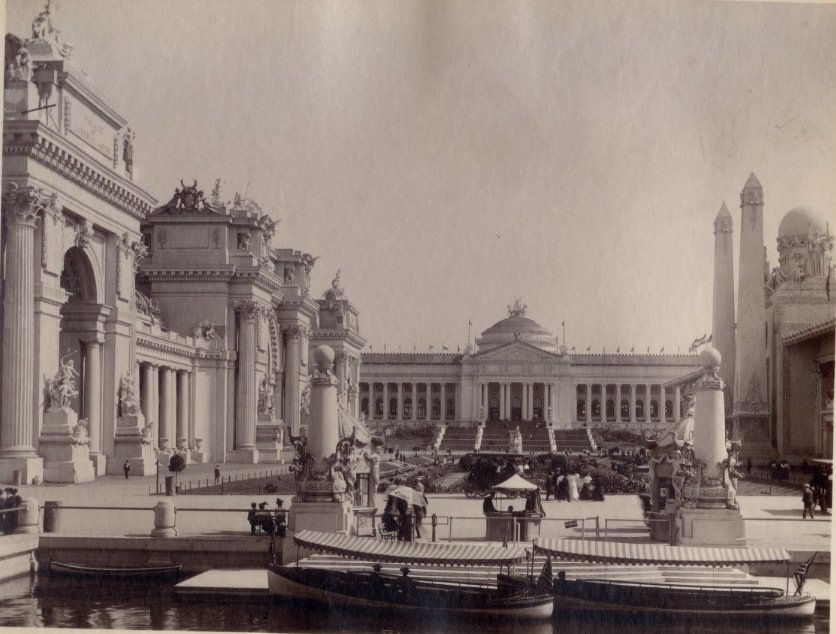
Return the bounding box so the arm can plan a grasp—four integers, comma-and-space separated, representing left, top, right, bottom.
575, 383, 682, 423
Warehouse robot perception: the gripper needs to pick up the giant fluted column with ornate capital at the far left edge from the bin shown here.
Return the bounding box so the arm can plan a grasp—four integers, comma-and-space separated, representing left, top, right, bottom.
0, 186, 47, 482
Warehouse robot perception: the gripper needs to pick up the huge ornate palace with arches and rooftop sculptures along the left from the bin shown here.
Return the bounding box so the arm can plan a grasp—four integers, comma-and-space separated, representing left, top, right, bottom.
0, 7, 365, 482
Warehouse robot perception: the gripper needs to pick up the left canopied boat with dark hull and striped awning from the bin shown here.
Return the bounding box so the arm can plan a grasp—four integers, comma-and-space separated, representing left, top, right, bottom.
268, 531, 554, 619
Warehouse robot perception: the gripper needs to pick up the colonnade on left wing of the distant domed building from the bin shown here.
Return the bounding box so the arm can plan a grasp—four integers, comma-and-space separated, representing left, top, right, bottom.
360, 381, 458, 421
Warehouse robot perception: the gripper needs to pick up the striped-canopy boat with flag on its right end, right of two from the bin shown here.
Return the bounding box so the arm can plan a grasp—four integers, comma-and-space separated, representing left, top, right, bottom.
534, 539, 816, 618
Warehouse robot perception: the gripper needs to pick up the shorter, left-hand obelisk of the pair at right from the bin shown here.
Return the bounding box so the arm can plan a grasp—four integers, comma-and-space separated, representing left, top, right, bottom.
711, 203, 734, 396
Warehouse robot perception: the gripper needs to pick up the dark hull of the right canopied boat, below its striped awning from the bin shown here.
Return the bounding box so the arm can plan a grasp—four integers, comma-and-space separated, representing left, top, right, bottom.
555, 581, 816, 619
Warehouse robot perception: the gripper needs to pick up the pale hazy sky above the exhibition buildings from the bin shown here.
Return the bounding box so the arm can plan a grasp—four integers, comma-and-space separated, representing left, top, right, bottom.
6, 0, 836, 352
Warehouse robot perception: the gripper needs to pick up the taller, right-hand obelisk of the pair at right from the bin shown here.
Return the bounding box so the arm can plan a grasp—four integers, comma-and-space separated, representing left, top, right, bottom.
732, 174, 769, 453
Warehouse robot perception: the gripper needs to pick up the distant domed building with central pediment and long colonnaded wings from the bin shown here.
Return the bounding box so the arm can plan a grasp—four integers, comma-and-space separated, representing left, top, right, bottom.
360, 302, 697, 429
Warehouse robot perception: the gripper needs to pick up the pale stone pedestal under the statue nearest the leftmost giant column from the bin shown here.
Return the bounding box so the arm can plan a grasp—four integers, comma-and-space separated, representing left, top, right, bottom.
39, 407, 96, 483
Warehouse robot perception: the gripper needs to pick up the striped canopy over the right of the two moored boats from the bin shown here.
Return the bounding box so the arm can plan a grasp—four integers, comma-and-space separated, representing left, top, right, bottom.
534, 538, 790, 566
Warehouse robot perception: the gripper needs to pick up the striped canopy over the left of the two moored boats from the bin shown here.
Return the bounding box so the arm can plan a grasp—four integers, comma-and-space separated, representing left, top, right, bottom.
294, 531, 525, 566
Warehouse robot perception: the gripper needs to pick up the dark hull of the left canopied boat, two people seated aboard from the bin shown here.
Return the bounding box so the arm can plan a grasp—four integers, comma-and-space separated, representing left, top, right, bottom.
268, 566, 554, 620
